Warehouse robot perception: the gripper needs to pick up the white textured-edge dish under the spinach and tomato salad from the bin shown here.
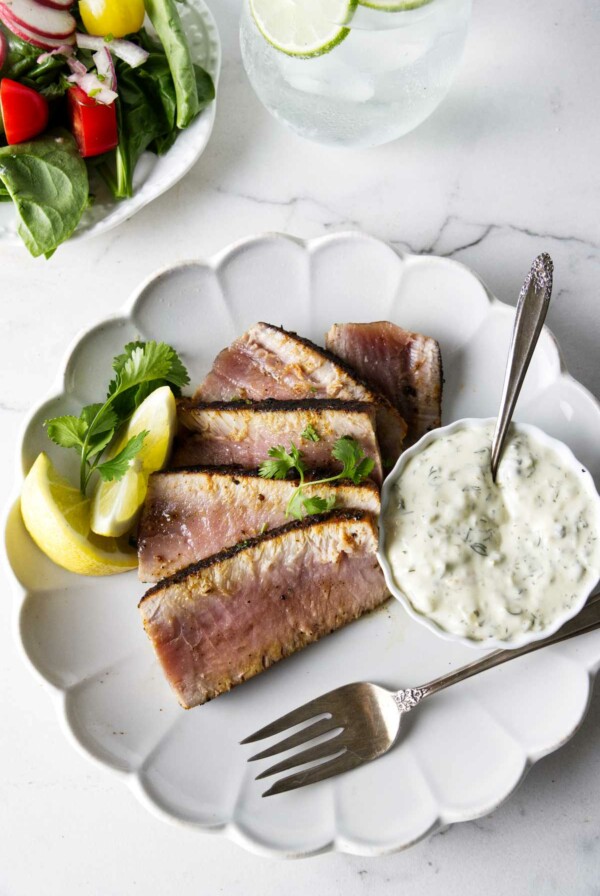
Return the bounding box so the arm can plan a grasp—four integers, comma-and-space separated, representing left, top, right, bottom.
0, 0, 221, 245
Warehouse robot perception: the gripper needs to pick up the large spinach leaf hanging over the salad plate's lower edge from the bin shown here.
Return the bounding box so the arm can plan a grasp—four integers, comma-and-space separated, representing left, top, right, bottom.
0, 128, 89, 258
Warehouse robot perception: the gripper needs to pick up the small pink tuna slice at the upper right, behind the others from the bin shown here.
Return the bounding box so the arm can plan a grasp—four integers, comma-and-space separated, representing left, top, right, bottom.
326, 321, 443, 447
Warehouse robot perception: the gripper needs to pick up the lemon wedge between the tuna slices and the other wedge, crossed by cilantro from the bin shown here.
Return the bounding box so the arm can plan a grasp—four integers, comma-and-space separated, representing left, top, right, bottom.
91, 386, 177, 537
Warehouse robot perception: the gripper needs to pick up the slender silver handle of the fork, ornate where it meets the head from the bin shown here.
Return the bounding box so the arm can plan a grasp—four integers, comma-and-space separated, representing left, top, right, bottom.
393, 591, 600, 712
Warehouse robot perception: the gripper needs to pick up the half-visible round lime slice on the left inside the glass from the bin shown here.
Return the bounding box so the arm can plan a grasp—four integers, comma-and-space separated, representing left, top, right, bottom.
250, 0, 358, 58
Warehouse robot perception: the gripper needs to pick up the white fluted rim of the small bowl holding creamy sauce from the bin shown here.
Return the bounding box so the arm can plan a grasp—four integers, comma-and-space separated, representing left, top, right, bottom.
377, 417, 600, 650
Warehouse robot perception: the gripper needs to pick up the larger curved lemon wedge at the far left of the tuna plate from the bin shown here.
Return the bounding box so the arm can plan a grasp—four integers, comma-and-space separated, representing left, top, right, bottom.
21, 452, 137, 576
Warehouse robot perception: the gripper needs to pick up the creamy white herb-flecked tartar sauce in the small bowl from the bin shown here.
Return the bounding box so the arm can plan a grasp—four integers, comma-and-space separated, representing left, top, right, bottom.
385, 422, 600, 641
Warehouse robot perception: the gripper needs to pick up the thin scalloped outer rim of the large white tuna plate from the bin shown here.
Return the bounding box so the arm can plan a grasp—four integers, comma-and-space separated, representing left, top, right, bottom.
0, 231, 600, 858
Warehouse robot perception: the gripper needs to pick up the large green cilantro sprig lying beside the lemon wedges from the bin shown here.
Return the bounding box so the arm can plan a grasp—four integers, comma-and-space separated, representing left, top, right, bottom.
44, 341, 190, 495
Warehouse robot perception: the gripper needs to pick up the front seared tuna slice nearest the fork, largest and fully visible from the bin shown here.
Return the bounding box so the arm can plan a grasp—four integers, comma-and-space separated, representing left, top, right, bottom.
139, 510, 388, 709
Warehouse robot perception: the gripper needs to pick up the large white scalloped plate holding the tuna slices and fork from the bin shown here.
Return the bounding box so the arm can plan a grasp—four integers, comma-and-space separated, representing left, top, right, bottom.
6, 233, 600, 856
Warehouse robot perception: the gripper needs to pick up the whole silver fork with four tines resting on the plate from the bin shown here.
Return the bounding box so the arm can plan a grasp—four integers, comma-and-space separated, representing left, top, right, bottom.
241, 591, 600, 796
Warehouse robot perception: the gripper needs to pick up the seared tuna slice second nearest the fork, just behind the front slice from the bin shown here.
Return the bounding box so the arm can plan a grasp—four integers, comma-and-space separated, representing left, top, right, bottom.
137, 467, 380, 582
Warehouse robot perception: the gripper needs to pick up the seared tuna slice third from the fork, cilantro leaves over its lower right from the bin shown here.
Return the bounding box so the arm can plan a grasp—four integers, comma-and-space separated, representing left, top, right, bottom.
171, 399, 382, 484
